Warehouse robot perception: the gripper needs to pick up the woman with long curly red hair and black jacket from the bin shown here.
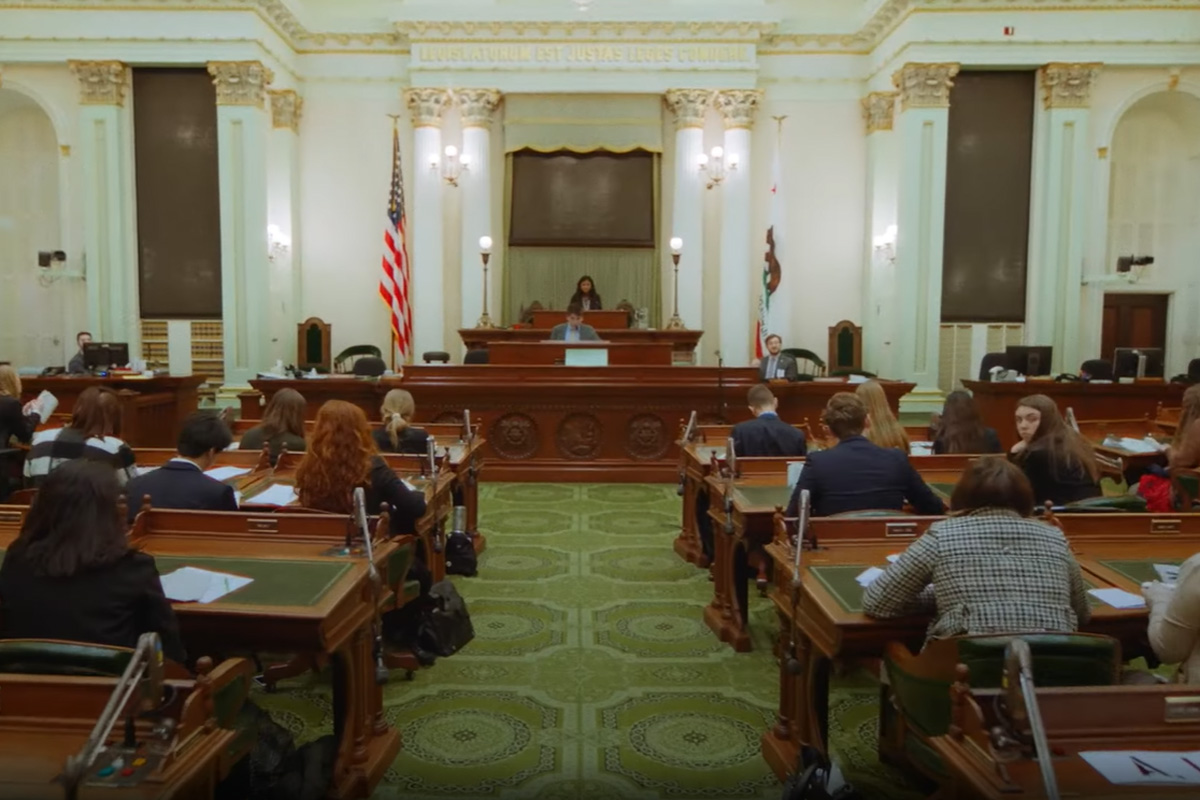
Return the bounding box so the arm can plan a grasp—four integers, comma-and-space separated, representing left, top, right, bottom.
295, 401, 425, 535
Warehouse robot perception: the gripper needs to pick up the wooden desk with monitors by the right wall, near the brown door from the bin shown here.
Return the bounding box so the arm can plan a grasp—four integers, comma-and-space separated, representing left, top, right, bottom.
962, 380, 1184, 451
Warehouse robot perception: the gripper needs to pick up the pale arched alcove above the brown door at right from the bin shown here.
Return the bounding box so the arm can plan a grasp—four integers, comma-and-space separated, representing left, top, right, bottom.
1105, 91, 1200, 372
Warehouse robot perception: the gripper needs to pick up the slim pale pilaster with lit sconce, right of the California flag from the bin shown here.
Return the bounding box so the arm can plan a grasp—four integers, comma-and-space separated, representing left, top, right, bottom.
862, 91, 901, 378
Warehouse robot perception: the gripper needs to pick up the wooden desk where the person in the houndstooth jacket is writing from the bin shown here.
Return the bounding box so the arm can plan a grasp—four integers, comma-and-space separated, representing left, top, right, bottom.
762, 513, 1200, 777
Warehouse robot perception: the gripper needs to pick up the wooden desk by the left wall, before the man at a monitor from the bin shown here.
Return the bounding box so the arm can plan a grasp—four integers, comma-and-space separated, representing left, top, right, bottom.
20, 375, 206, 447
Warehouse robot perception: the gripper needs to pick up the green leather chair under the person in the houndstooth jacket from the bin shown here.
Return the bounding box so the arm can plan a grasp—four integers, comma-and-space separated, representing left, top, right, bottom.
880, 633, 1122, 781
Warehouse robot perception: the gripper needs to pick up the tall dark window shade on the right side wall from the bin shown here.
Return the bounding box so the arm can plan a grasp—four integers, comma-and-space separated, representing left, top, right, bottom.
942, 72, 1036, 323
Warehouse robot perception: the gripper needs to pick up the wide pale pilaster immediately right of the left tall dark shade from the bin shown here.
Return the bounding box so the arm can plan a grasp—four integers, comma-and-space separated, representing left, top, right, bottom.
209, 61, 274, 386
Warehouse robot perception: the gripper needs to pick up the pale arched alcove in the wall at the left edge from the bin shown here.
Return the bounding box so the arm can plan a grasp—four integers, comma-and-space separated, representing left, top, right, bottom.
0, 89, 64, 366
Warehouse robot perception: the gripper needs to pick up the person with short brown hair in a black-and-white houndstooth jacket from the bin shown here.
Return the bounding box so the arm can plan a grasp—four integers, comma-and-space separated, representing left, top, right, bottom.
863, 458, 1091, 640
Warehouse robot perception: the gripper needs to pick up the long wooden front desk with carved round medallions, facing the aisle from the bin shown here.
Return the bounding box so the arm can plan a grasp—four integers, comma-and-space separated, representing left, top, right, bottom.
242, 374, 913, 482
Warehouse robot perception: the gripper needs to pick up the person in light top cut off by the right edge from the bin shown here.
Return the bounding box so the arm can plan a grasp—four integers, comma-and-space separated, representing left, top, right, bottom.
1141, 553, 1200, 684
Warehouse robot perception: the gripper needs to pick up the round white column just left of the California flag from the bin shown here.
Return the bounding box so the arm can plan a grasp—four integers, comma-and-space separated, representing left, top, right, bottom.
716, 89, 762, 366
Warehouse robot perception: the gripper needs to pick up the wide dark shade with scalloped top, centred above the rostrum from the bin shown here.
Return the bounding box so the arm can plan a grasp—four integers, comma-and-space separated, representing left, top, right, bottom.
509, 150, 654, 247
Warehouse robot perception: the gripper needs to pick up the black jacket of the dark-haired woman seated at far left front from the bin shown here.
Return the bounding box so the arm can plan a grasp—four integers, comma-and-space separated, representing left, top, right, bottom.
0, 549, 187, 663
